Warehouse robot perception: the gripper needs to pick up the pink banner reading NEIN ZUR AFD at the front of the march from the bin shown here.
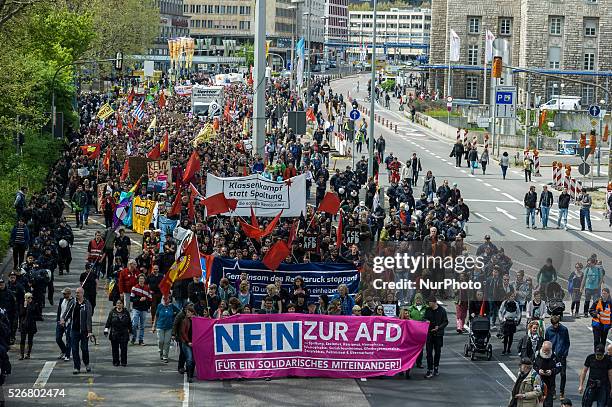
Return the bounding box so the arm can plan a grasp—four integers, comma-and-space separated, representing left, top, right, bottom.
192, 314, 429, 380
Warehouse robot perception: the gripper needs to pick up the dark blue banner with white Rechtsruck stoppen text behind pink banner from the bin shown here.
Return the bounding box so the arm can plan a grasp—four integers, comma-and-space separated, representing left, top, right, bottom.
210, 257, 360, 307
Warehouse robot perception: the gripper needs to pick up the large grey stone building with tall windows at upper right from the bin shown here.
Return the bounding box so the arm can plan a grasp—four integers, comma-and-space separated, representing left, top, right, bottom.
429, 0, 612, 105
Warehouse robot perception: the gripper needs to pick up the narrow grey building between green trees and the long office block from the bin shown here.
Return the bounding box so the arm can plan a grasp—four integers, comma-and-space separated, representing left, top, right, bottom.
149, 0, 189, 69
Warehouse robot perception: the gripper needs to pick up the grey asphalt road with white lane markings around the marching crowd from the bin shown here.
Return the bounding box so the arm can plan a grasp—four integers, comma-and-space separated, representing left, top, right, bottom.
3, 76, 612, 407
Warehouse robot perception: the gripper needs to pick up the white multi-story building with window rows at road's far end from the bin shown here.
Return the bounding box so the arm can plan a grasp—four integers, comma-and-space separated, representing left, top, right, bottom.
348, 8, 431, 61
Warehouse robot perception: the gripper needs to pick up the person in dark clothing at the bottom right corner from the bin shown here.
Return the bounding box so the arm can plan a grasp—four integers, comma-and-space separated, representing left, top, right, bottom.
578, 344, 612, 407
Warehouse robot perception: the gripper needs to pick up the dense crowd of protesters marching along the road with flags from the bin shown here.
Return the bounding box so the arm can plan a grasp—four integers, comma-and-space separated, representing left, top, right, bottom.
0, 71, 612, 407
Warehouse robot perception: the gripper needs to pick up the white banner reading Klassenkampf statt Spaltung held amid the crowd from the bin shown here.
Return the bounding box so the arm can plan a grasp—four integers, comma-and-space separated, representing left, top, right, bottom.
206, 174, 306, 217
